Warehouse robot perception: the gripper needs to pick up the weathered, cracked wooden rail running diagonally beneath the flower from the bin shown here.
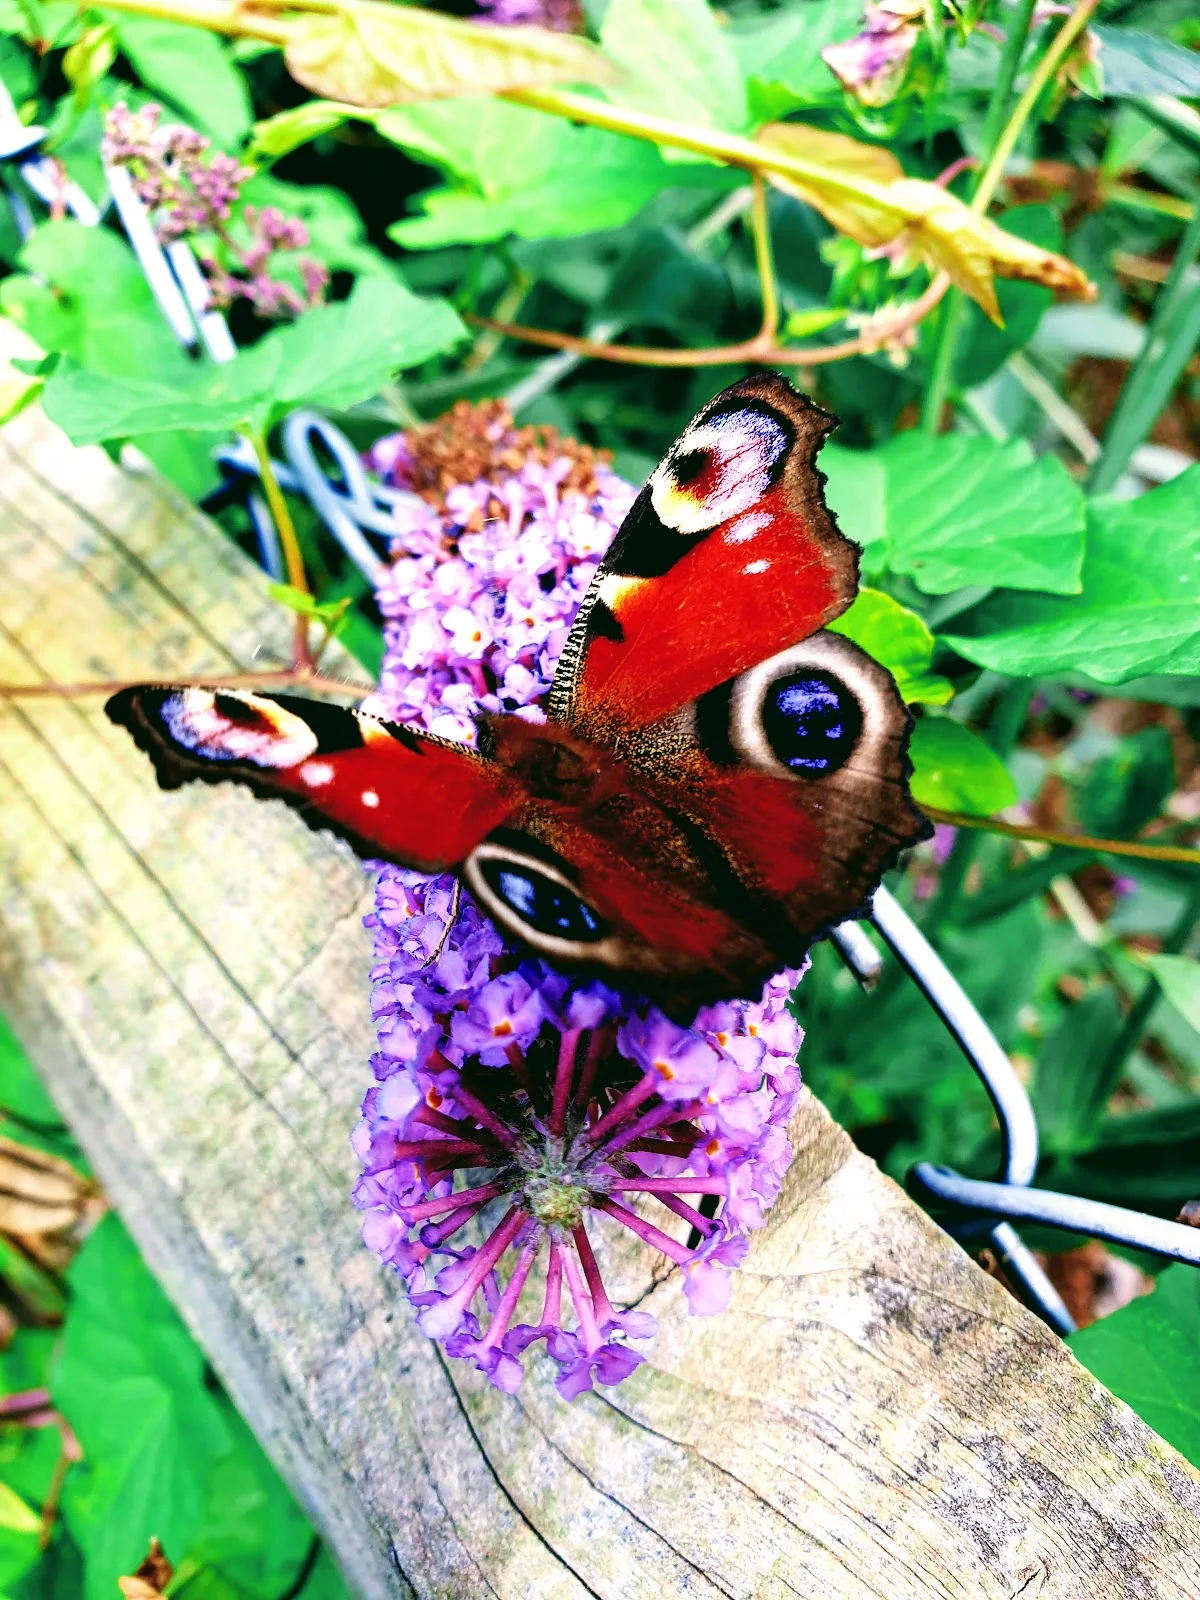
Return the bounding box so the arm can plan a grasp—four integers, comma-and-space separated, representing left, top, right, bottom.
0, 387, 1200, 1600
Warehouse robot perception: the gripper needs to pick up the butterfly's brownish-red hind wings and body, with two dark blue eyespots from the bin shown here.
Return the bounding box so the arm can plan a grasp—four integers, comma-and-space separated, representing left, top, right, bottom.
464, 630, 930, 1021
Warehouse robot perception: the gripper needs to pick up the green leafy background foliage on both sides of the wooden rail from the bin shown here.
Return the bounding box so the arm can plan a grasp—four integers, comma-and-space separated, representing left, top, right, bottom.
0, 0, 1200, 1600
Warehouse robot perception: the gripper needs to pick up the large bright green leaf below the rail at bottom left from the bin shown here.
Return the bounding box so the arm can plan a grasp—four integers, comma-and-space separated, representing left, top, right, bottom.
51, 1213, 230, 1600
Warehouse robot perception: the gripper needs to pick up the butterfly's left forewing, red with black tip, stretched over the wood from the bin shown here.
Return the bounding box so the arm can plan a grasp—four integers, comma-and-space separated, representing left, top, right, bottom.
106, 683, 520, 872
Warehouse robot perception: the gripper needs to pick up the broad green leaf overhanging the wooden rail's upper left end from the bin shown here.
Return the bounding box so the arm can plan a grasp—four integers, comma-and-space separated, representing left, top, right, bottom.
43, 277, 462, 445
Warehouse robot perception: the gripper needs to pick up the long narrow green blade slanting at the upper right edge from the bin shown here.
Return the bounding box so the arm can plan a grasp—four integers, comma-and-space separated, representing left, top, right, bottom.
1085, 206, 1200, 494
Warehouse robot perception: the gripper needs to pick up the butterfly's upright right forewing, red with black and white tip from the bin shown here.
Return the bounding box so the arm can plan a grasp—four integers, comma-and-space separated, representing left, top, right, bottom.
550, 373, 858, 749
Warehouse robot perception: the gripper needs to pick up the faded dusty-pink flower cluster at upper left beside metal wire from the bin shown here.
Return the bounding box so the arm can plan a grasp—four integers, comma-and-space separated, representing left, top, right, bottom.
101, 101, 330, 318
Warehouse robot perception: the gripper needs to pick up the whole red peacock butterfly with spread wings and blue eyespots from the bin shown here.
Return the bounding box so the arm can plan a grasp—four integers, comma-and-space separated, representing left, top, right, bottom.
107, 373, 928, 1021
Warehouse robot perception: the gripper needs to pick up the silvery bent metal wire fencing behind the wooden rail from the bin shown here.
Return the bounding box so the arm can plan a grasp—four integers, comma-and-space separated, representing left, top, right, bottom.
0, 100, 1200, 1334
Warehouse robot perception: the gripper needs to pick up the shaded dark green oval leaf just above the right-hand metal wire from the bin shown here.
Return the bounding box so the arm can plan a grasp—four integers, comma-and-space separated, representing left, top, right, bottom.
1030, 986, 1122, 1150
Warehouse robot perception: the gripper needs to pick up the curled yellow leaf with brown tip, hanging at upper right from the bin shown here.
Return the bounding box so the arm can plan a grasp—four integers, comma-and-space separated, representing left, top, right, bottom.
757, 122, 1094, 323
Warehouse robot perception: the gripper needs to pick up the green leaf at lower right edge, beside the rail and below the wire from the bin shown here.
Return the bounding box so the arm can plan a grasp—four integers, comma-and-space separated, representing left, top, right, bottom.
1067, 1264, 1200, 1467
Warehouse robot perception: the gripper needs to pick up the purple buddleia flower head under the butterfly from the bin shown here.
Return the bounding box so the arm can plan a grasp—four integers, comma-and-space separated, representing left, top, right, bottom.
354, 419, 800, 1398
